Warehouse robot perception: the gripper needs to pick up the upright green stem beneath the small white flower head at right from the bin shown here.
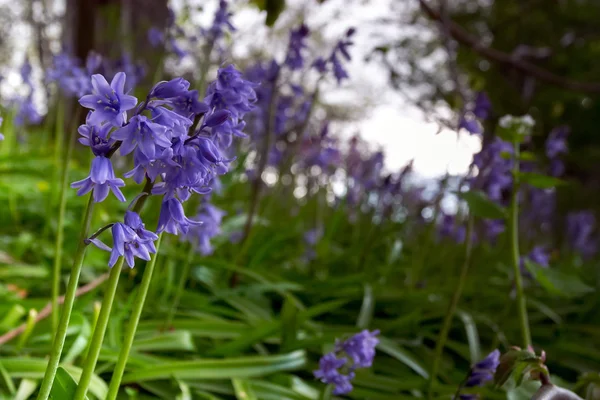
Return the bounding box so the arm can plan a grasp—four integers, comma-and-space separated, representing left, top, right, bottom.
509, 143, 531, 348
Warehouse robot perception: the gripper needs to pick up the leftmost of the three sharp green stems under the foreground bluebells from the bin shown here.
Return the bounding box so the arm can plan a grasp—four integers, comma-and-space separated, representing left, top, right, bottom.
37, 194, 94, 400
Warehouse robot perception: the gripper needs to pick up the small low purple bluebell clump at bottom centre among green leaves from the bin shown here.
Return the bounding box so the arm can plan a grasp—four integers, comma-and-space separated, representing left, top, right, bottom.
314, 330, 379, 395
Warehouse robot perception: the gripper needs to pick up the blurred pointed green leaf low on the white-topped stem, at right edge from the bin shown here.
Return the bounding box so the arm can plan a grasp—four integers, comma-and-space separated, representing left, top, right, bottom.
525, 260, 595, 297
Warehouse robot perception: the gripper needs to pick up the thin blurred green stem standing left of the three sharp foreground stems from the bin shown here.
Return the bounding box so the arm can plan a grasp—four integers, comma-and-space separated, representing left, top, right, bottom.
52, 106, 80, 332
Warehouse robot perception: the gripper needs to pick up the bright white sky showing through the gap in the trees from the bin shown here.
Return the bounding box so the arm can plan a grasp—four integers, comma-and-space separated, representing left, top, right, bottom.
220, 0, 481, 178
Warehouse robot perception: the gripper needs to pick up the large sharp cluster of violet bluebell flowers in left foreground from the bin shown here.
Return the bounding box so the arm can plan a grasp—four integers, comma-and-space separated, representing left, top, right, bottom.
71, 65, 255, 267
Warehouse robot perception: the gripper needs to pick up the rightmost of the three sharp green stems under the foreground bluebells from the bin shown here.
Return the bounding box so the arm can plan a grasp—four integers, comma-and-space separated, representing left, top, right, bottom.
106, 233, 162, 400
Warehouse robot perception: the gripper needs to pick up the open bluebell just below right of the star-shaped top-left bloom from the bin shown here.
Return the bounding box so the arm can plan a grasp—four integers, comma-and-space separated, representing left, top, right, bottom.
112, 115, 171, 160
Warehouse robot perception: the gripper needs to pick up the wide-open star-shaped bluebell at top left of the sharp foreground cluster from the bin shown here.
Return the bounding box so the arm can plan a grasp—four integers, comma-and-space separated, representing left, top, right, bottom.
79, 72, 137, 127
